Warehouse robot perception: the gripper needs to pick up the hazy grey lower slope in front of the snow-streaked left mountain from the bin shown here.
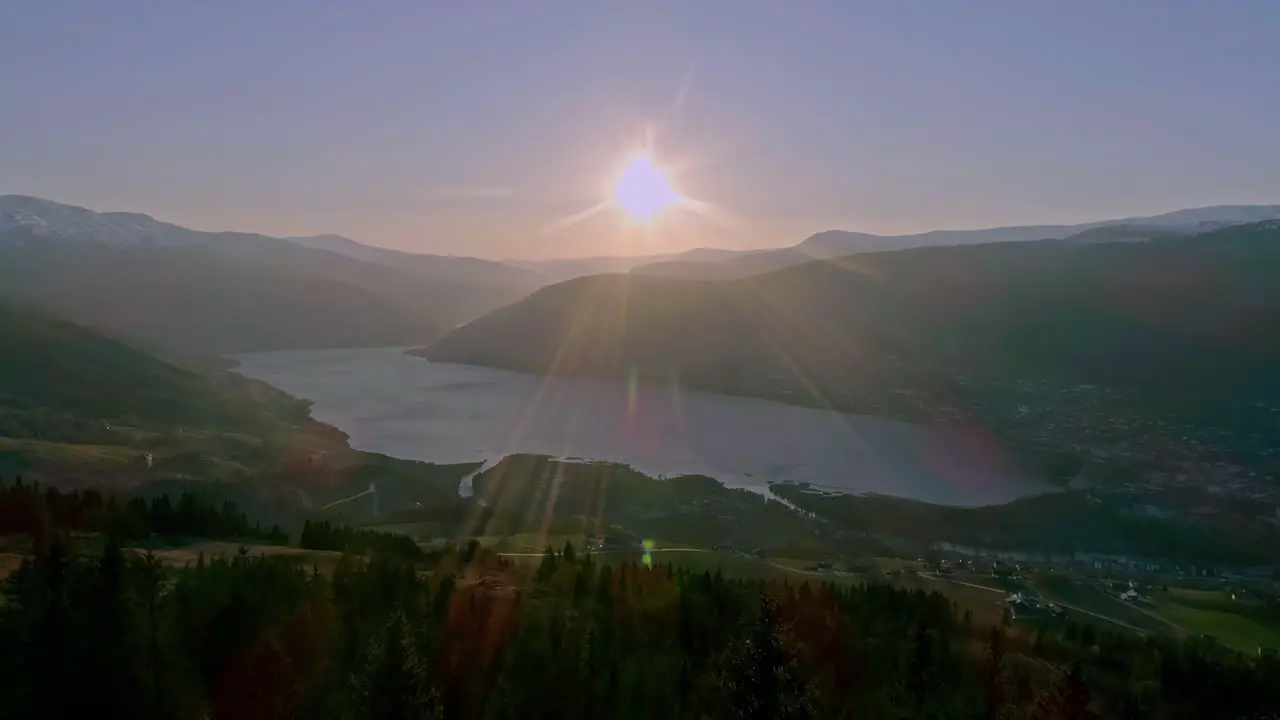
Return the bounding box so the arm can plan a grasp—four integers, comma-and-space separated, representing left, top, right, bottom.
0, 242, 444, 354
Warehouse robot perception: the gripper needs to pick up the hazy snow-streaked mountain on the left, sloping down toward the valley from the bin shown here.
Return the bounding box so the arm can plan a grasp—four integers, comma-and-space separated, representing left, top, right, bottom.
0, 195, 524, 354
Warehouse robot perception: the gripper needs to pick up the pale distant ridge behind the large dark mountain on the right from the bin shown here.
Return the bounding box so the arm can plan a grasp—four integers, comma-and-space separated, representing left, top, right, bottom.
631, 205, 1280, 279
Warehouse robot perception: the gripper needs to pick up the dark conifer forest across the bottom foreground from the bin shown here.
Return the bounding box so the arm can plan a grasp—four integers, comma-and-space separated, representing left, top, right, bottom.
0, 525, 1280, 720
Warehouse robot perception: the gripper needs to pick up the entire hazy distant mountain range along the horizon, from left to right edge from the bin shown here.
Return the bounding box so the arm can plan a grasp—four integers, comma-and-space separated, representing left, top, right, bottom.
0, 195, 1280, 354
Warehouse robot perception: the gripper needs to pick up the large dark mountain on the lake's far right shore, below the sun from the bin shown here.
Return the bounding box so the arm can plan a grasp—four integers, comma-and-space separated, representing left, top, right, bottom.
422, 222, 1280, 430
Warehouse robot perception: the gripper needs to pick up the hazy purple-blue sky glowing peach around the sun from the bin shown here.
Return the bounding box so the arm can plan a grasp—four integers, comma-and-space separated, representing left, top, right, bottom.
0, 0, 1280, 259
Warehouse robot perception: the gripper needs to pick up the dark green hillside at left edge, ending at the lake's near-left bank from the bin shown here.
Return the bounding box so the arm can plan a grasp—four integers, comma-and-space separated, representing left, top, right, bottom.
0, 302, 325, 486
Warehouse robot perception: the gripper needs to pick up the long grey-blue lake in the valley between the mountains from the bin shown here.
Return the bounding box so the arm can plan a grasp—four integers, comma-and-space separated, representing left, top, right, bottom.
237, 348, 1053, 506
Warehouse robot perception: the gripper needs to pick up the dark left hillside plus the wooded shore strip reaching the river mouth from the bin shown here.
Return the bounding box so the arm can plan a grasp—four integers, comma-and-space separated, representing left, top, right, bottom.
0, 302, 479, 515
